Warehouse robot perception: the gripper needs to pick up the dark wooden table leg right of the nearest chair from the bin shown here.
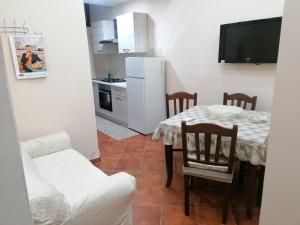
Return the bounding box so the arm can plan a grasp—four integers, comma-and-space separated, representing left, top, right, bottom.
246, 163, 257, 219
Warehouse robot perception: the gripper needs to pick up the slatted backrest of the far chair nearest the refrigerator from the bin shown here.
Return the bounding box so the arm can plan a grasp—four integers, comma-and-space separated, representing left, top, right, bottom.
166, 92, 197, 118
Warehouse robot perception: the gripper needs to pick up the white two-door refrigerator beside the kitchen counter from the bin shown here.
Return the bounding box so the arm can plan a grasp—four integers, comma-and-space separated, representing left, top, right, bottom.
125, 57, 165, 134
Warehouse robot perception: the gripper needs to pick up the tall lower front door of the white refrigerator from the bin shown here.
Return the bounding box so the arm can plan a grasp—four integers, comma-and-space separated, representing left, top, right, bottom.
127, 77, 145, 133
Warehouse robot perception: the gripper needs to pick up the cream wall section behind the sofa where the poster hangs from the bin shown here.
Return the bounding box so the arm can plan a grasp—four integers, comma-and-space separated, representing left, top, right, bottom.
0, 0, 99, 159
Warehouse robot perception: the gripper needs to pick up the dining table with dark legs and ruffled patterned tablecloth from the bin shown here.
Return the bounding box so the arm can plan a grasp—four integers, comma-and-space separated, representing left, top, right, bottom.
152, 105, 271, 218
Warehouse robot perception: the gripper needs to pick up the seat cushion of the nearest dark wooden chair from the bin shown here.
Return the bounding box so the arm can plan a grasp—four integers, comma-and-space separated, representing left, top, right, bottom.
183, 167, 233, 183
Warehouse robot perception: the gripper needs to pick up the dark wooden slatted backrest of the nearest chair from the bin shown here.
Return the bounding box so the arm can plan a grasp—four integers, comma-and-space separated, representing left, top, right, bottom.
181, 122, 238, 173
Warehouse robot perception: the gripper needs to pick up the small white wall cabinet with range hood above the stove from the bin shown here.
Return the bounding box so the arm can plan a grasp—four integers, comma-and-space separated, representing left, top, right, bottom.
92, 20, 118, 44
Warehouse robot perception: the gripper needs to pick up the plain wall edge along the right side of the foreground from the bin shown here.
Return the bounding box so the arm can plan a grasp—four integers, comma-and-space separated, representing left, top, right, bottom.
260, 0, 300, 225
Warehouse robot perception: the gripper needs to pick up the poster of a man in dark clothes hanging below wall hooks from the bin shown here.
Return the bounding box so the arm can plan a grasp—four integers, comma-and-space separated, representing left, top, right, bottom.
9, 35, 47, 79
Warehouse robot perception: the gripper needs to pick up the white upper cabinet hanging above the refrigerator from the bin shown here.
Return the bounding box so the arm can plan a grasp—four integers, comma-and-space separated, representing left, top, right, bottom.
117, 13, 149, 53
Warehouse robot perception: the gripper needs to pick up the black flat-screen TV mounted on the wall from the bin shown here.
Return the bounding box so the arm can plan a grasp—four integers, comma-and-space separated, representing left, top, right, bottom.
218, 17, 282, 64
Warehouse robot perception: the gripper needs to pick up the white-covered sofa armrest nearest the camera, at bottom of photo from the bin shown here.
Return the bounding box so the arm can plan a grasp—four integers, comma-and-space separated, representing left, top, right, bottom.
66, 172, 136, 225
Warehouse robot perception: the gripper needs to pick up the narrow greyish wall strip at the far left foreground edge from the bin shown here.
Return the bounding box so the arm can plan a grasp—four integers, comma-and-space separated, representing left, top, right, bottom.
0, 39, 32, 225
